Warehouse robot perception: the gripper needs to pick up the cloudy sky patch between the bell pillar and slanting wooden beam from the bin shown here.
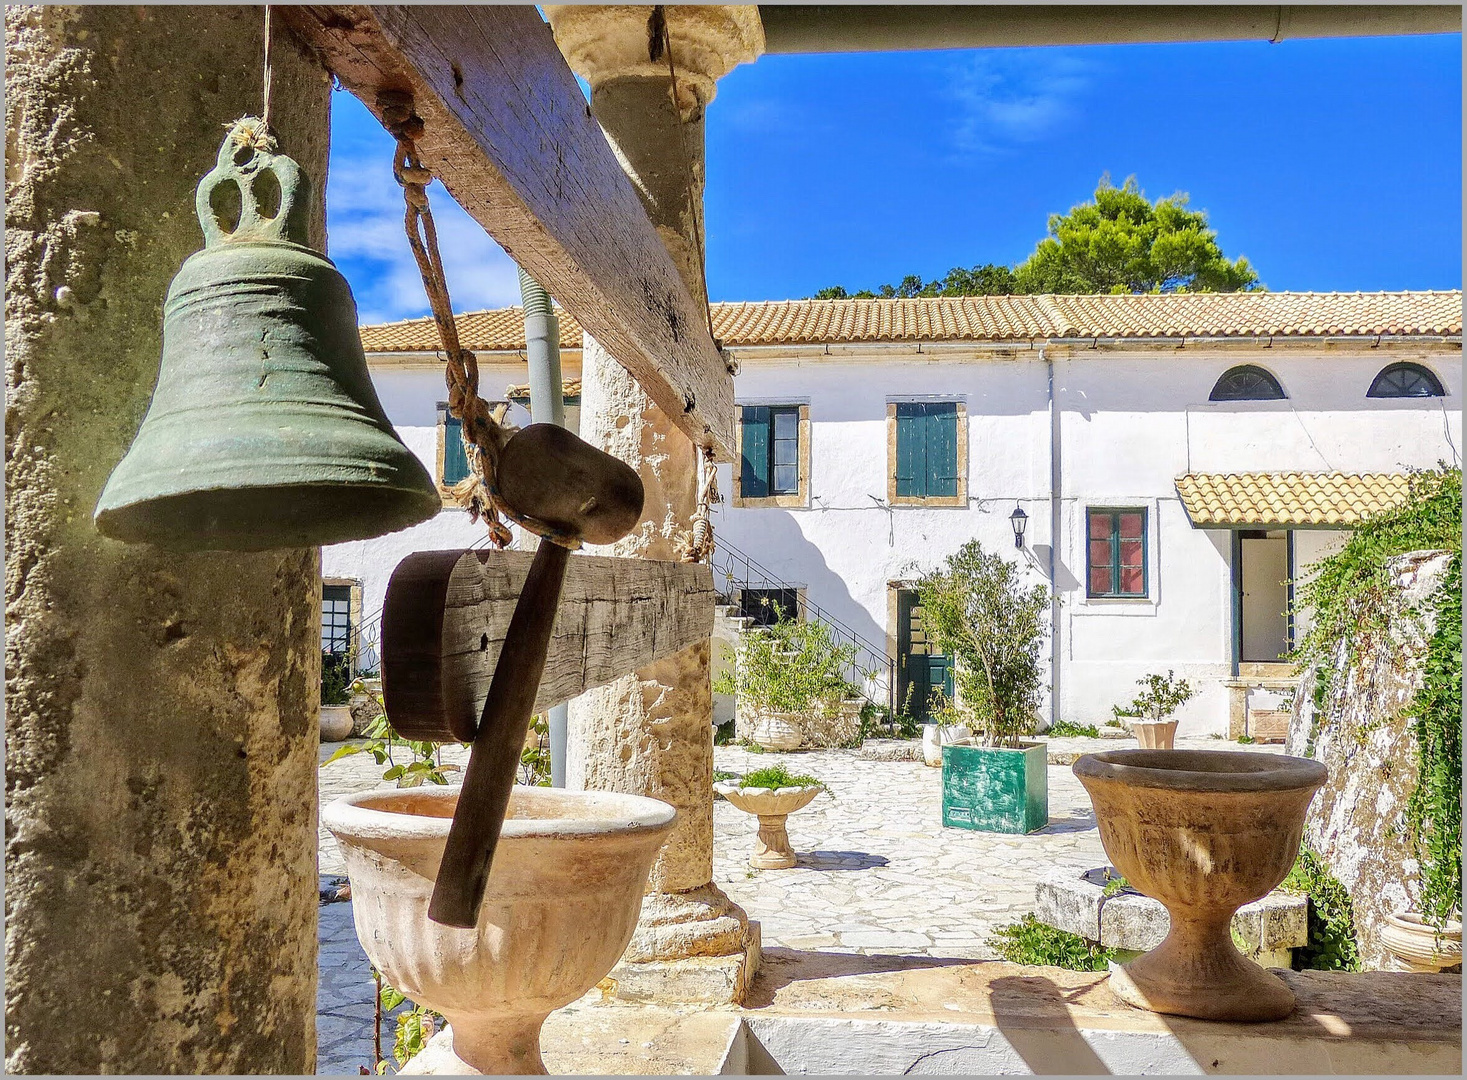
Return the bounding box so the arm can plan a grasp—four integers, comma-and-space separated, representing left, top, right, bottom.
326, 139, 519, 324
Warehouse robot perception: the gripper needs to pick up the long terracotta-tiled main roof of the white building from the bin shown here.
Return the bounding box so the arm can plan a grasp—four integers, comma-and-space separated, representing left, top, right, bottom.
352, 291, 1463, 352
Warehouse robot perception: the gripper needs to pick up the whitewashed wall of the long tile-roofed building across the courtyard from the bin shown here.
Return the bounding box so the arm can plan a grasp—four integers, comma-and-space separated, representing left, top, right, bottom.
323, 345, 1463, 732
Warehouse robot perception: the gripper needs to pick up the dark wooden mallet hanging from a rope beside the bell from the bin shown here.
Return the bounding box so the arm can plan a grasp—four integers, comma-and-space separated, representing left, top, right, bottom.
420, 424, 643, 927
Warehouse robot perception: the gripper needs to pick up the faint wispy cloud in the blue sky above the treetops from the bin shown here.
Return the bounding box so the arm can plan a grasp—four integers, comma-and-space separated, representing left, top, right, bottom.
948, 48, 1094, 154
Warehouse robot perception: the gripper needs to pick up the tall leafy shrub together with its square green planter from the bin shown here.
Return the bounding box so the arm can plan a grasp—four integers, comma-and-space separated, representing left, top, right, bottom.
917, 540, 1049, 832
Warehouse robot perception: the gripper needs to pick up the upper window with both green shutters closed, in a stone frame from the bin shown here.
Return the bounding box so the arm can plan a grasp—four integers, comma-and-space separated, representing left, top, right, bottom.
886, 401, 968, 506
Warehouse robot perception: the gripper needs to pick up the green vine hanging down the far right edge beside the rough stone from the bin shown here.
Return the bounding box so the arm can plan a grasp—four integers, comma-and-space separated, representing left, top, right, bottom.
1405, 553, 1463, 927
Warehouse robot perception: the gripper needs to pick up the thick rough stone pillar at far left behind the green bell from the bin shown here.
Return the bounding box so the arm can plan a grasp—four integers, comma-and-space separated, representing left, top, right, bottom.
4, 6, 330, 1074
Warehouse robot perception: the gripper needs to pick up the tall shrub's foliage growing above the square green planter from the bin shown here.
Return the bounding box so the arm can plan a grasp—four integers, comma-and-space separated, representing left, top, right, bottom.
917, 540, 1049, 747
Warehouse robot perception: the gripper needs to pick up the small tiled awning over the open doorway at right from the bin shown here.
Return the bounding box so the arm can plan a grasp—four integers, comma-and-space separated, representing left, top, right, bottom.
1177, 473, 1410, 528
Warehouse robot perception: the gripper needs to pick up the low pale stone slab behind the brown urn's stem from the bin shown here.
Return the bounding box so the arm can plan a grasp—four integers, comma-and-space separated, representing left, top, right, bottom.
1034, 870, 1309, 967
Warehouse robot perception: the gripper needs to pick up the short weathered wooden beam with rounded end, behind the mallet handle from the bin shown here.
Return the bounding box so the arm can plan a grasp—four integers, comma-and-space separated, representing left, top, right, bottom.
381, 549, 713, 741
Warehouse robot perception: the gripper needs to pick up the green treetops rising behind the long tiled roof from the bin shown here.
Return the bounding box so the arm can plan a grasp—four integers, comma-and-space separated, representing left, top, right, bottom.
814, 175, 1262, 299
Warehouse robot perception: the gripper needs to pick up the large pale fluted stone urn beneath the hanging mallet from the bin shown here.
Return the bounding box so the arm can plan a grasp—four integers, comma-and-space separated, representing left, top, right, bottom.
321, 787, 676, 1074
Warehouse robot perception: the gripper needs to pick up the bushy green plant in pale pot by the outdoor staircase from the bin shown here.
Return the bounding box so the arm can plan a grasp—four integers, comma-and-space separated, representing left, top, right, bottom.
713, 616, 861, 750
